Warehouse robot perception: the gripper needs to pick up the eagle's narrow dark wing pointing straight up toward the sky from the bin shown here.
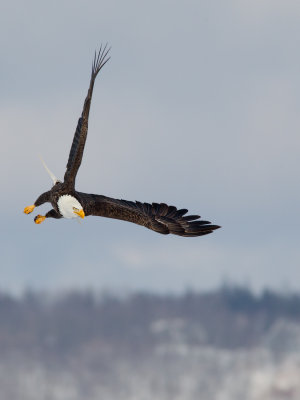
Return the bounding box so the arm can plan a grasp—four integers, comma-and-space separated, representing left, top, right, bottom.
64, 45, 110, 188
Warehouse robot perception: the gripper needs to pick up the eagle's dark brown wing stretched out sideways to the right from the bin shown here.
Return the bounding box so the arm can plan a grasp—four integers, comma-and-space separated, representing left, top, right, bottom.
77, 192, 220, 237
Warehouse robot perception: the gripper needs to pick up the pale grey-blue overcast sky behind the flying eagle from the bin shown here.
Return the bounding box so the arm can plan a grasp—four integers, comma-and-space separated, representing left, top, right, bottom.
0, 0, 300, 293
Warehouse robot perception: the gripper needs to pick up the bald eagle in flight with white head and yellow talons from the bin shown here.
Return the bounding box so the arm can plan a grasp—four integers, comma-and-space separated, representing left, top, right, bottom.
24, 45, 220, 237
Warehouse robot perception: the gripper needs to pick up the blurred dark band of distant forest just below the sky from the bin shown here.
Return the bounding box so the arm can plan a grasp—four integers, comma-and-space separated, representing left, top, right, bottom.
0, 287, 300, 357
